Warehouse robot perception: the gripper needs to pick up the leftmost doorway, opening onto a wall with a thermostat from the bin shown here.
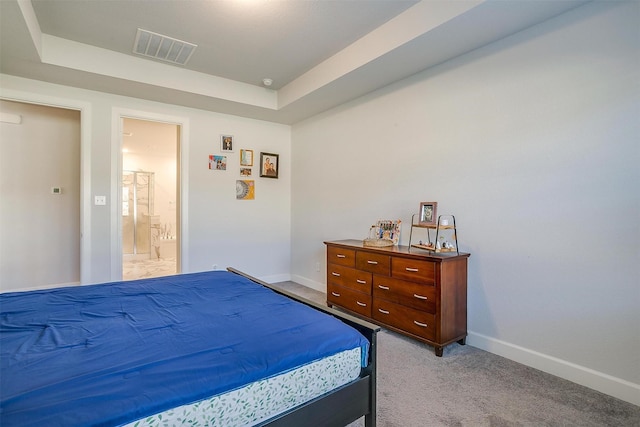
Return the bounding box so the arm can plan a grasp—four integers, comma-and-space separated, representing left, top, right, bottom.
0, 99, 82, 291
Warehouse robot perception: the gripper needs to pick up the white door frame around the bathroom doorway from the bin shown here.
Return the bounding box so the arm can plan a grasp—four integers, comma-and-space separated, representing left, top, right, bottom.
110, 108, 189, 281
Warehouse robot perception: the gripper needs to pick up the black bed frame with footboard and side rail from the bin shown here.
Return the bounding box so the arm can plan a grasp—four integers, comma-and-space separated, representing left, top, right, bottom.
227, 267, 380, 427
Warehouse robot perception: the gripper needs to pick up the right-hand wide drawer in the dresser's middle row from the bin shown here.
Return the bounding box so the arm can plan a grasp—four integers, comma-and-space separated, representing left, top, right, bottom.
373, 276, 436, 314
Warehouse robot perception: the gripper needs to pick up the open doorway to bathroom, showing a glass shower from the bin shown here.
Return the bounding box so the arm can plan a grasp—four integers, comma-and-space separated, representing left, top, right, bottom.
121, 118, 180, 280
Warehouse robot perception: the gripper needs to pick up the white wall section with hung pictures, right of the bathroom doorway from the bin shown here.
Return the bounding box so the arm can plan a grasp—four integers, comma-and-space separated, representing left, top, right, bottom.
180, 107, 291, 281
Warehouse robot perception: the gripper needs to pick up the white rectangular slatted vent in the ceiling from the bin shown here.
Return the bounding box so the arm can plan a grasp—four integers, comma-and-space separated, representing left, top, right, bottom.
133, 28, 198, 65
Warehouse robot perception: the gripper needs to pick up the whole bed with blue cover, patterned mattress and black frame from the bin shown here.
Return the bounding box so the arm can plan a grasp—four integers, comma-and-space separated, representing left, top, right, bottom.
0, 268, 379, 427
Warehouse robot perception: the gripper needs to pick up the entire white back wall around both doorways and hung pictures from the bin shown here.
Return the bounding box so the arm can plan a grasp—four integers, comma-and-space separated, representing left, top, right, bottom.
0, 75, 291, 283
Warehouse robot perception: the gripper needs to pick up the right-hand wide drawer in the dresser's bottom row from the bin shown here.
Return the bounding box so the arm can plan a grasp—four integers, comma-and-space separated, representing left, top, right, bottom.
372, 299, 436, 340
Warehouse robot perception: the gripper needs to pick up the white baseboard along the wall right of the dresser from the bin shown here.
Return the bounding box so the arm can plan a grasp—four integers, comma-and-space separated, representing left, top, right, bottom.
467, 331, 640, 406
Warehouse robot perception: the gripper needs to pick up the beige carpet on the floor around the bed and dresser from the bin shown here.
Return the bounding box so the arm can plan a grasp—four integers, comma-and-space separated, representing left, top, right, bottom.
278, 282, 640, 427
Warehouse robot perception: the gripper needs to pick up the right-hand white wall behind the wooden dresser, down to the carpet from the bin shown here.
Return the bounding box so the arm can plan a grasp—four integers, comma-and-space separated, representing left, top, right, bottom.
292, 2, 640, 404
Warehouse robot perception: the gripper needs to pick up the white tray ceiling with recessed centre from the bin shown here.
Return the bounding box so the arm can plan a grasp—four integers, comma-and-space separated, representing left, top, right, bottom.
0, 0, 586, 124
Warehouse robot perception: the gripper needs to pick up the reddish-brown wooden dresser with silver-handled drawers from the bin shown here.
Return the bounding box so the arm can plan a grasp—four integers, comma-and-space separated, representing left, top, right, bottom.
325, 240, 469, 356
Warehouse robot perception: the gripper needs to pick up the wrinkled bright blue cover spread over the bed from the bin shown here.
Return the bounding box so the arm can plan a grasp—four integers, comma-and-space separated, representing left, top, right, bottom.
0, 271, 368, 427
